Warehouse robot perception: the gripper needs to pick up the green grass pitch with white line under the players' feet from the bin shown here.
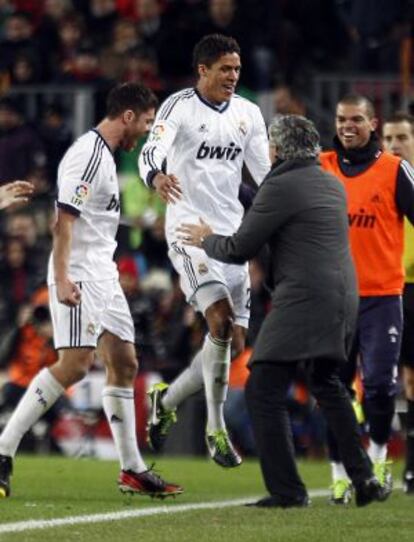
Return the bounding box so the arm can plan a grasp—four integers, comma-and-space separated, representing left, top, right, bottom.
0, 456, 414, 542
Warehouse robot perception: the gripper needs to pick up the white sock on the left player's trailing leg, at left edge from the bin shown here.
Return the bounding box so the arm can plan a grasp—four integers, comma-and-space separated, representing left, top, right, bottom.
0, 368, 65, 457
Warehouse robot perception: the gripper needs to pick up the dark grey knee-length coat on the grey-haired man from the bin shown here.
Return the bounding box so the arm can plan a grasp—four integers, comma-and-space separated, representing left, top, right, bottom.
203, 159, 358, 363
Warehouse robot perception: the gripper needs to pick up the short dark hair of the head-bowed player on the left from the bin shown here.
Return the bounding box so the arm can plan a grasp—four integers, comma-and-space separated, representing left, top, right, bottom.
106, 83, 158, 119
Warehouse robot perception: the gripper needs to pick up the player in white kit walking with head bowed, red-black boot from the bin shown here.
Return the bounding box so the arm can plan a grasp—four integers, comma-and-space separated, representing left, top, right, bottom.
0, 83, 182, 497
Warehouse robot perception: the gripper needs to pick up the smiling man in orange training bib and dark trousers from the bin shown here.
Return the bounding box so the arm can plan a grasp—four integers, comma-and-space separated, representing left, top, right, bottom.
320, 95, 414, 504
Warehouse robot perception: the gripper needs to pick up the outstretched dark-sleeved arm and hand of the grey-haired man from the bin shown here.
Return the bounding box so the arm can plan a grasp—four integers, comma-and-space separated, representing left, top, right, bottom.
178, 177, 292, 264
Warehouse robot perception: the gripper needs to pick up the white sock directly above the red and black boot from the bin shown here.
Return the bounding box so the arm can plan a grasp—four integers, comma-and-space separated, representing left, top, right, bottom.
102, 386, 147, 472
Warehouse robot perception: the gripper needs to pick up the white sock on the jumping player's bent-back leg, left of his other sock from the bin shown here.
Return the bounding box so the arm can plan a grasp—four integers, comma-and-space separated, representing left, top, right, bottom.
162, 349, 203, 410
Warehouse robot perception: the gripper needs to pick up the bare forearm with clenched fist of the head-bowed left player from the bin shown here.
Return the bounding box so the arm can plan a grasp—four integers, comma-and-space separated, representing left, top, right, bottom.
53, 209, 81, 307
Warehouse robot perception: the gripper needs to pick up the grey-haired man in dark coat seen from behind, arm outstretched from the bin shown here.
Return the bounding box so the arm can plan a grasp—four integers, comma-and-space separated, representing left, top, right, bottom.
180, 115, 385, 507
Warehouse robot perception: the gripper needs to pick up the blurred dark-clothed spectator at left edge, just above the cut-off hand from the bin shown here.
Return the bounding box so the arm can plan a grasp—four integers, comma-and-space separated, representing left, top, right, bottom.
0, 98, 46, 182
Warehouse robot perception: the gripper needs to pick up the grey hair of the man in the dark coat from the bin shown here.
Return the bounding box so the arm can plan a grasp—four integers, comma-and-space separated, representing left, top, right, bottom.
269, 115, 321, 160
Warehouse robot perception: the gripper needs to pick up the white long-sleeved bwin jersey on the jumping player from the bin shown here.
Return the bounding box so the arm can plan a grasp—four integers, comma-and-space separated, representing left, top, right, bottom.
139, 88, 270, 243
